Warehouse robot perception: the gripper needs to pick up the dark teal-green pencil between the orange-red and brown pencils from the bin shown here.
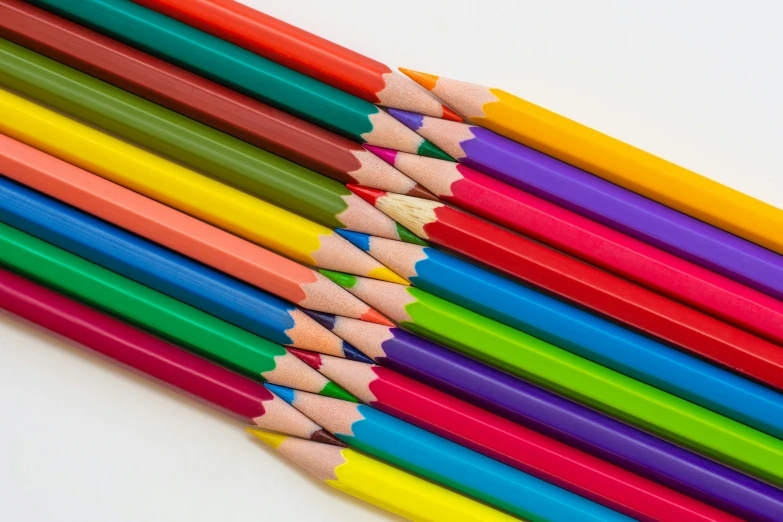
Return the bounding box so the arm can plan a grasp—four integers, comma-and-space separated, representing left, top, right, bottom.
24, 0, 448, 159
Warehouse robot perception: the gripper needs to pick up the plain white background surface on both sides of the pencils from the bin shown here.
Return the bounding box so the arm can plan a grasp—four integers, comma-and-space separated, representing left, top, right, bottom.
0, 0, 783, 522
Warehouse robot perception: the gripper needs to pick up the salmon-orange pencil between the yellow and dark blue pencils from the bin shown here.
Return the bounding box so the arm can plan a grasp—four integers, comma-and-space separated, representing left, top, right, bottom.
0, 134, 391, 325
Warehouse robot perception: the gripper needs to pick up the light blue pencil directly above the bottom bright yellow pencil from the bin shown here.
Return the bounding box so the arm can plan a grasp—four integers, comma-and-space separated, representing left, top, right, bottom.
269, 385, 631, 522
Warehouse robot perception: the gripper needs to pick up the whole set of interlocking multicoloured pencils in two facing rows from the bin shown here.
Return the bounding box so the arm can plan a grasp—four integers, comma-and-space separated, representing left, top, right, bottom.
0, 0, 783, 522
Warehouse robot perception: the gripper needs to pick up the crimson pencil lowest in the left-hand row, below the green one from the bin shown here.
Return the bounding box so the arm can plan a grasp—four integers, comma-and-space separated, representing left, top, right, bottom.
0, 269, 342, 445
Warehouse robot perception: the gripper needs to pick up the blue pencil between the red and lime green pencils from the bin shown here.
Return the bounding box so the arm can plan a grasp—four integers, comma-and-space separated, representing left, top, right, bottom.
344, 232, 783, 430
